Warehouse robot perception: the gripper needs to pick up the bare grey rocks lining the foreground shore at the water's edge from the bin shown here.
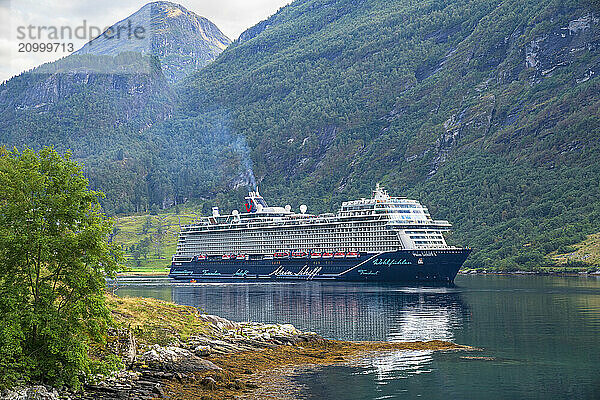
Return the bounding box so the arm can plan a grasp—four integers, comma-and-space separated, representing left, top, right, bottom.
2, 314, 322, 400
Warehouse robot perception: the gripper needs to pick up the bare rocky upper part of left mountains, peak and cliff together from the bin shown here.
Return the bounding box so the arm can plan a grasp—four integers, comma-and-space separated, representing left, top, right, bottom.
0, 1, 230, 116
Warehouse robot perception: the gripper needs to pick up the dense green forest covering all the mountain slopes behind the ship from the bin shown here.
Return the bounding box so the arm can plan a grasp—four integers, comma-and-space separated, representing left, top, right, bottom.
0, 0, 600, 269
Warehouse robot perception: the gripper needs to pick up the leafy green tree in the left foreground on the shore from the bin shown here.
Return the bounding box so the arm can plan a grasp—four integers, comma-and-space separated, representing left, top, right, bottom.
0, 148, 122, 387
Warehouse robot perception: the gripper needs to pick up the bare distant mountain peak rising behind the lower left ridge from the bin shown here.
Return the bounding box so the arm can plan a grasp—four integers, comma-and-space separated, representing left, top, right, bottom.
75, 1, 231, 82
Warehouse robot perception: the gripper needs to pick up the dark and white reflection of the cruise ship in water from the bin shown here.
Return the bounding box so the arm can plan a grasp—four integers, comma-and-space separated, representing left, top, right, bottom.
113, 281, 468, 383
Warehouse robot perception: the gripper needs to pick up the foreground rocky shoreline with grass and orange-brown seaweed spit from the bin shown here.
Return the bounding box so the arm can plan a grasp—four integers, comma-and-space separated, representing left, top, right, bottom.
2, 298, 468, 400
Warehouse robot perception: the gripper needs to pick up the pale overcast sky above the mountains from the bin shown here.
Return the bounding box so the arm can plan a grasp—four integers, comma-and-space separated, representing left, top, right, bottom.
0, 0, 291, 82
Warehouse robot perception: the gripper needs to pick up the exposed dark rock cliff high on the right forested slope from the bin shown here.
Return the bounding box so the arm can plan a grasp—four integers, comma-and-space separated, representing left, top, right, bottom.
407, 8, 600, 176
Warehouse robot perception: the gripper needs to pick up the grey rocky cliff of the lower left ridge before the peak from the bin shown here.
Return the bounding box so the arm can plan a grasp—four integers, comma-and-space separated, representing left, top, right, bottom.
0, 53, 172, 116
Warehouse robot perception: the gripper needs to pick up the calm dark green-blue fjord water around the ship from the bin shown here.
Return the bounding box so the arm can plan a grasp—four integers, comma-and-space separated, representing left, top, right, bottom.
117, 275, 600, 400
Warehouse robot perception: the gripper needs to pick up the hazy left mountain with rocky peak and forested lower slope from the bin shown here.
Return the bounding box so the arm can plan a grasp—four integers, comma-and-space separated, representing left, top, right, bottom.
0, 1, 235, 213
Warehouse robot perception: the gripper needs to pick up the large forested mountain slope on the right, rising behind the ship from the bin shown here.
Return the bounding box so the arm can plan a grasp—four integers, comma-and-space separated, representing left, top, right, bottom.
170, 0, 600, 268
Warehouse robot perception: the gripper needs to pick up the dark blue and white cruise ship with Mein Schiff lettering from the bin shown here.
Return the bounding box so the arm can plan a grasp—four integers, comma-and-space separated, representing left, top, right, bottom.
169, 185, 470, 283
